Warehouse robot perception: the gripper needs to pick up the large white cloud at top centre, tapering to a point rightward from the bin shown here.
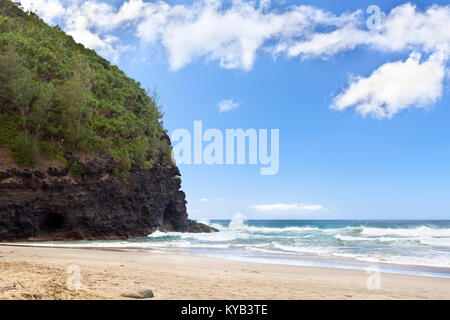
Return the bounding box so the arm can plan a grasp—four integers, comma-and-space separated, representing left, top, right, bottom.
132, 0, 360, 70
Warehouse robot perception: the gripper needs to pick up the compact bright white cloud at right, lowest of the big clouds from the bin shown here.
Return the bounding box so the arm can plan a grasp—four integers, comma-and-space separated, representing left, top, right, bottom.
331, 53, 445, 118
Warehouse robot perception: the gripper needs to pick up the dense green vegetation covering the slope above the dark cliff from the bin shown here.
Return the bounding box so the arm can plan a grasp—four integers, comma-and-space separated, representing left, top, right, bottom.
0, 0, 173, 168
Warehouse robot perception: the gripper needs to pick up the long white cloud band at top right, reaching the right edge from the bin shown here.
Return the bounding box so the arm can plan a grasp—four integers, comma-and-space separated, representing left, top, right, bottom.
280, 3, 450, 59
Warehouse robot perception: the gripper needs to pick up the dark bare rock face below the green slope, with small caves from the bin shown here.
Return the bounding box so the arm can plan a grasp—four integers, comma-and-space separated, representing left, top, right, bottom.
0, 154, 217, 241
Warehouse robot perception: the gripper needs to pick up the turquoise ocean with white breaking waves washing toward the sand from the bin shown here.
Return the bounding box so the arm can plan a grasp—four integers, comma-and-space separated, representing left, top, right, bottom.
11, 214, 450, 278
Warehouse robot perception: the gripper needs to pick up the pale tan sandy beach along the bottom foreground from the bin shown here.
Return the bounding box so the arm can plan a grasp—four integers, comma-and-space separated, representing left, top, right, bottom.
0, 245, 450, 300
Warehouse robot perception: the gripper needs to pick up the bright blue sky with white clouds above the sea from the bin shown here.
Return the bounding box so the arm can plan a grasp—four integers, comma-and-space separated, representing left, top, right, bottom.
21, 0, 450, 220
